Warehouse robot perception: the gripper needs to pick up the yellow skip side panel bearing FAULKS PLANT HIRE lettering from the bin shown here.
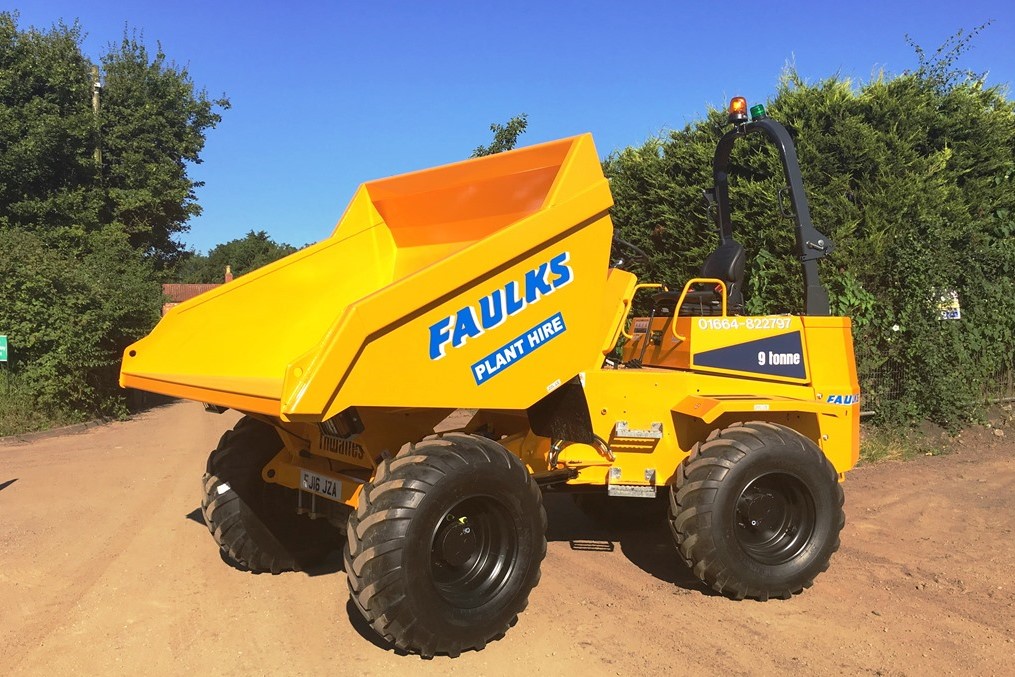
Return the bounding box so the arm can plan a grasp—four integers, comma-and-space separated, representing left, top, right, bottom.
283, 215, 613, 420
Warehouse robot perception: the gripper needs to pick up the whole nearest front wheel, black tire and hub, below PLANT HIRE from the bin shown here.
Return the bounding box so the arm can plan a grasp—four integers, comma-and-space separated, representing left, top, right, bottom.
345, 433, 546, 658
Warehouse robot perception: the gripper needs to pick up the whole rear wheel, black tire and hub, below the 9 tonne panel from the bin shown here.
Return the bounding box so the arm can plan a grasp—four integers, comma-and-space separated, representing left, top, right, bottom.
670, 421, 845, 601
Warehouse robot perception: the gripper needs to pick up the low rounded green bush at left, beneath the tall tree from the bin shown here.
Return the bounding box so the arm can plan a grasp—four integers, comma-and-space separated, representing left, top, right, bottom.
0, 227, 161, 413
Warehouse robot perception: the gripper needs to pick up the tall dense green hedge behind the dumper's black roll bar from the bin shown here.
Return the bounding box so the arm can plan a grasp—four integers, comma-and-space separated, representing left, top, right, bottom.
604, 30, 1015, 426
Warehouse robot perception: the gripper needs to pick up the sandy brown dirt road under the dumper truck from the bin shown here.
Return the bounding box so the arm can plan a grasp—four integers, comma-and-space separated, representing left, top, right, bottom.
0, 403, 1015, 676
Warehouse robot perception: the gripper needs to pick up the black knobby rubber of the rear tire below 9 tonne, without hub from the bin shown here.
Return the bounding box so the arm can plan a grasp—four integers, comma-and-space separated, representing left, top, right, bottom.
670, 421, 845, 601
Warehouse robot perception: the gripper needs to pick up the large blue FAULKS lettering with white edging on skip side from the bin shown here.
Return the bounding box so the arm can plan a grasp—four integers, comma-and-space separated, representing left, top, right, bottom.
429, 252, 574, 360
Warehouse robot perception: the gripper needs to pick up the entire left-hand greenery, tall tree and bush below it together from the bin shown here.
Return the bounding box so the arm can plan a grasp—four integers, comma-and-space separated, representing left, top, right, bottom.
0, 12, 228, 425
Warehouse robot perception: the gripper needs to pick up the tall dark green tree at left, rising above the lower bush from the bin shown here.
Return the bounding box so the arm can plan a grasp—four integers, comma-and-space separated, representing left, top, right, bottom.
0, 12, 229, 267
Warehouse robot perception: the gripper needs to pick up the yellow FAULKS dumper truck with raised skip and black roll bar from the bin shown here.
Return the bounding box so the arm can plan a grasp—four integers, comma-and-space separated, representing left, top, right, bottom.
121, 98, 860, 657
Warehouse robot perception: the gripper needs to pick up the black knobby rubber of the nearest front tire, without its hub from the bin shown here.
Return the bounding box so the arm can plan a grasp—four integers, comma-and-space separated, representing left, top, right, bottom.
345, 433, 546, 658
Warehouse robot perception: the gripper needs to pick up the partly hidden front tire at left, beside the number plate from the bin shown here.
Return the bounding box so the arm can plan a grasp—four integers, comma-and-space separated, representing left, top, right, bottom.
201, 416, 342, 573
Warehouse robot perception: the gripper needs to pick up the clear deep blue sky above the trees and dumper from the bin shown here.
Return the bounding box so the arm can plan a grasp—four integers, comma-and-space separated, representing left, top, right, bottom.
9, 0, 1015, 251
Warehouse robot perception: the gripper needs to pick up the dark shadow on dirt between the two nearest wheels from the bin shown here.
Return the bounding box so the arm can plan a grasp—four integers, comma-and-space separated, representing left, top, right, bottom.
543, 493, 718, 597
